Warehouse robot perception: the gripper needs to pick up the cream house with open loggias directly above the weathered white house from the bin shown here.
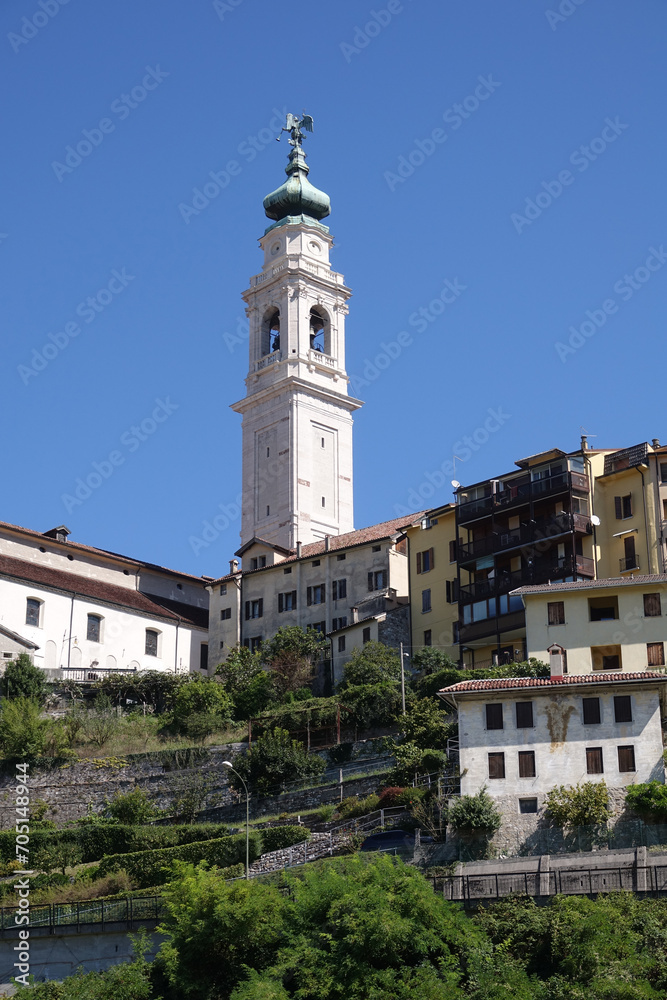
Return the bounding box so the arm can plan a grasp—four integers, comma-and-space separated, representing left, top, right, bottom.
513, 575, 667, 674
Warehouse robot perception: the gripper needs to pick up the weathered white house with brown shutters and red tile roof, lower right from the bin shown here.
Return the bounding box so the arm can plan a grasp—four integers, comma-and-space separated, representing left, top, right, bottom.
439, 671, 667, 816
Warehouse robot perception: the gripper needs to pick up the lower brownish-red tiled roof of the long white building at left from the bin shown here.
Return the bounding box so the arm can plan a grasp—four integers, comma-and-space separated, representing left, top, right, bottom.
0, 555, 202, 628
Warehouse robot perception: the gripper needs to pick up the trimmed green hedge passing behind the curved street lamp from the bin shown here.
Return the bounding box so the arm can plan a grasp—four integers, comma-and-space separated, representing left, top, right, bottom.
99, 831, 262, 889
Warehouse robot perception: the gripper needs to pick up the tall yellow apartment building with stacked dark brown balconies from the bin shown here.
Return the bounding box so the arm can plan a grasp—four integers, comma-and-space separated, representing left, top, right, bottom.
422, 437, 667, 666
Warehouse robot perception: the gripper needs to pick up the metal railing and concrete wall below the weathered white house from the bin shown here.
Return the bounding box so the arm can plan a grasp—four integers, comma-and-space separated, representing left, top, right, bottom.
432, 865, 667, 906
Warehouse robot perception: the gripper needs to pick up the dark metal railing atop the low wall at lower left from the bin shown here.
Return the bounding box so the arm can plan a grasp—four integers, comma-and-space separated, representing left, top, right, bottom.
0, 896, 164, 933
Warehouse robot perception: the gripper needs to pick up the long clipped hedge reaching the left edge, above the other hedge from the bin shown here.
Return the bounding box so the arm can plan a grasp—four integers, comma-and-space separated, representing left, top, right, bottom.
0, 823, 229, 862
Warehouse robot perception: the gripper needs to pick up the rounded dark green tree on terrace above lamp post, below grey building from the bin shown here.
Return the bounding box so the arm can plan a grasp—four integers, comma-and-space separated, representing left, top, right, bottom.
230, 727, 326, 792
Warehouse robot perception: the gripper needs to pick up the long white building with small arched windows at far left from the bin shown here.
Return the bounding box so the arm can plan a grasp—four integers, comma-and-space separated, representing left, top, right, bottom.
0, 524, 208, 680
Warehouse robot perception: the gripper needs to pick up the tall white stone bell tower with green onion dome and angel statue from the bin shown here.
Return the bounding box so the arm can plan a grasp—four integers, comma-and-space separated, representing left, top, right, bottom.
232, 115, 362, 549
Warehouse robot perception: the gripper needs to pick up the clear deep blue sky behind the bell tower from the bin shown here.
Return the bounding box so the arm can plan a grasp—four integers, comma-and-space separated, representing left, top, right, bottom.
0, 0, 667, 576
